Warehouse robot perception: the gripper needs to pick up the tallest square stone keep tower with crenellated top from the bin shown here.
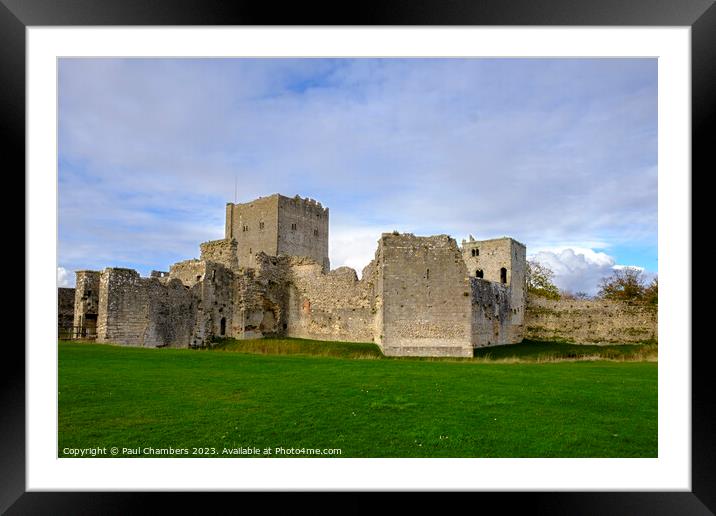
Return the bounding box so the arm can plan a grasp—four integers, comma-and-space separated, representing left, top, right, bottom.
225, 194, 330, 271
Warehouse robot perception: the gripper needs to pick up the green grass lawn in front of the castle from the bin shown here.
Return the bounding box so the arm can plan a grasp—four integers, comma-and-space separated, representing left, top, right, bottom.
58, 339, 657, 457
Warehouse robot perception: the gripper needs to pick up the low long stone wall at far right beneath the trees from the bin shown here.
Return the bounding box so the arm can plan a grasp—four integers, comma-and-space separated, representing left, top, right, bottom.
525, 296, 658, 344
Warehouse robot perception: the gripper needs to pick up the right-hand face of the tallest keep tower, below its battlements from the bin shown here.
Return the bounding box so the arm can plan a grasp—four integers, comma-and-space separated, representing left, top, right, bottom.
276, 195, 330, 272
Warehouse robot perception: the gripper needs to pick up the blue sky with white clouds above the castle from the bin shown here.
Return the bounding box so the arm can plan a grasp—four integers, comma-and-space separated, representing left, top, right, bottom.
58, 59, 657, 293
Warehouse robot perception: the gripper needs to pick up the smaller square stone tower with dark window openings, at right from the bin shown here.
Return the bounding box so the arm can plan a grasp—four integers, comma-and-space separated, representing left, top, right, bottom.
462, 237, 527, 325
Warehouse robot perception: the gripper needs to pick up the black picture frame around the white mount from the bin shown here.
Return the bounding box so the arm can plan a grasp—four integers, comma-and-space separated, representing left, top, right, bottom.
0, 0, 716, 515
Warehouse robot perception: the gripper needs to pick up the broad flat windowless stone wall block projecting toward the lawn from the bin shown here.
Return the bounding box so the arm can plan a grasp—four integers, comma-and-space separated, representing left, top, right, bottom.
379, 233, 473, 356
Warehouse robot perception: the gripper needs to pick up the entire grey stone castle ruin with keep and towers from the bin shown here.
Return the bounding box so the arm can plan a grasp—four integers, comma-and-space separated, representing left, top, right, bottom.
73, 194, 526, 357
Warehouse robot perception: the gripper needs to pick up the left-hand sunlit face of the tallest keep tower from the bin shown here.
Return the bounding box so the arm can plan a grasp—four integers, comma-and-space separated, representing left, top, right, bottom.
225, 194, 279, 267
